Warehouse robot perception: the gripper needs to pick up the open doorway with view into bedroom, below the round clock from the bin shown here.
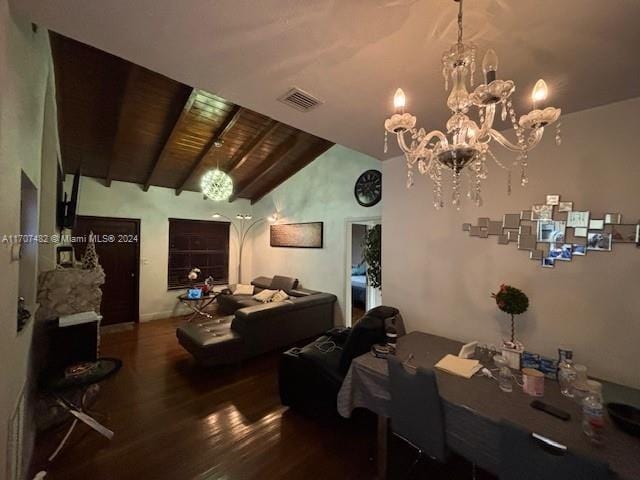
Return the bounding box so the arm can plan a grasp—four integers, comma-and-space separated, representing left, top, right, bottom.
345, 218, 382, 326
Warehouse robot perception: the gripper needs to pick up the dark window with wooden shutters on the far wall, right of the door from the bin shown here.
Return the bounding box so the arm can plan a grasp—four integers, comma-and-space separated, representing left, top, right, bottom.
168, 218, 229, 290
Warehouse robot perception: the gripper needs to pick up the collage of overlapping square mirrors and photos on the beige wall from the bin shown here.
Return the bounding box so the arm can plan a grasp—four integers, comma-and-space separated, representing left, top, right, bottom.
462, 195, 640, 268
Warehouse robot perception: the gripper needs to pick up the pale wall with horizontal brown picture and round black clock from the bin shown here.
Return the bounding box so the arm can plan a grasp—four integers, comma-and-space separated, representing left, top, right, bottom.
252, 145, 384, 324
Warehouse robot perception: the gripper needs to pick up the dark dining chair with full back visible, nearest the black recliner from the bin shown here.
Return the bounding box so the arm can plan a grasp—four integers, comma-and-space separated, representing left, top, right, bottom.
388, 357, 449, 478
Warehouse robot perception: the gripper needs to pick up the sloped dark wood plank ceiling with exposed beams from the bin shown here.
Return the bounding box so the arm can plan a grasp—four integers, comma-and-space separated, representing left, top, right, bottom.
51, 33, 333, 203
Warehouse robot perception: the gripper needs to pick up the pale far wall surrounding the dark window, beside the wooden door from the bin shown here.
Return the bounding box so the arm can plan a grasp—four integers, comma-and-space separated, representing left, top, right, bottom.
65, 175, 251, 321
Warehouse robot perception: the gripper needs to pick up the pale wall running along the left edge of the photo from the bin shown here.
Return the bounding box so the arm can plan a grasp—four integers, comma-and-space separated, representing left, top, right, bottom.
0, 0, 57, 480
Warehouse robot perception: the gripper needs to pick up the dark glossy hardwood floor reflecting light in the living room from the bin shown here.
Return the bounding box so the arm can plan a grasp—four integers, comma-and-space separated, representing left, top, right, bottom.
33, 318, 496, 480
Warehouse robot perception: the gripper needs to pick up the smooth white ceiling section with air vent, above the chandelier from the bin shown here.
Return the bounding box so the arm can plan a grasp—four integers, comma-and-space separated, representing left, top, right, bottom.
13, 0, 640, 158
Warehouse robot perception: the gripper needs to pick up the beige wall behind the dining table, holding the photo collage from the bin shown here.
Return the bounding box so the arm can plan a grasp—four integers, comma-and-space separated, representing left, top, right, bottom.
382, 99, 640, 387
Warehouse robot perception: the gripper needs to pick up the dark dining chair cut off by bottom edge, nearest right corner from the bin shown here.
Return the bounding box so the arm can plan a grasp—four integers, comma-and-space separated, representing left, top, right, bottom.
498, 420, 611, 480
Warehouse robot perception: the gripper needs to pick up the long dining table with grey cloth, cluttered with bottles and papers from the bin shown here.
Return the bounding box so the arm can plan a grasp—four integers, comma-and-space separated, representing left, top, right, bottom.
337, 331, 640, 480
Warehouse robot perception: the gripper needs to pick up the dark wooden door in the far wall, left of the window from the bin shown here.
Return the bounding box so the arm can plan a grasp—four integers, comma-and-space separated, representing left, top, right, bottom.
73, 215, 140, 325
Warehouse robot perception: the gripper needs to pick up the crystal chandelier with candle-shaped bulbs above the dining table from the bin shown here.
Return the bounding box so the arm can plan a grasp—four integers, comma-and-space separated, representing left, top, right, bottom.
384, 0, 561, 209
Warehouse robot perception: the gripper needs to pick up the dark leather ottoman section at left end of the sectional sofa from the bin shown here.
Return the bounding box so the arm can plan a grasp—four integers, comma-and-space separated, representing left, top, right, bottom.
176, 315, 244, 366
